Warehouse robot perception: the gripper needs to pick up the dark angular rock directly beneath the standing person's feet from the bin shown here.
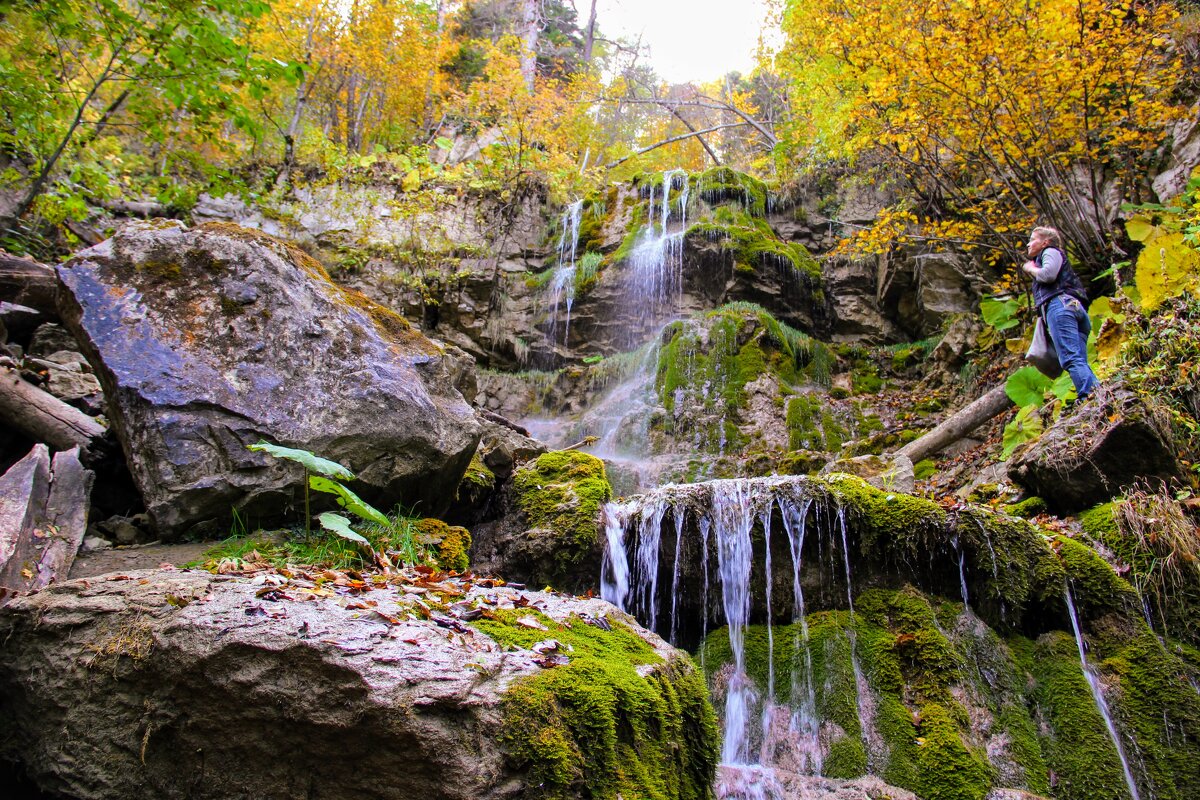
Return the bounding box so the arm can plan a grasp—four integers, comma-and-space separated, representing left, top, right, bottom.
1008, 386, 1181, 511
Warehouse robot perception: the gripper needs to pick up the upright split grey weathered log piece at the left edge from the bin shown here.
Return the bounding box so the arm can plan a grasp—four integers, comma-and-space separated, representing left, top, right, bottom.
0, 444, 94, 600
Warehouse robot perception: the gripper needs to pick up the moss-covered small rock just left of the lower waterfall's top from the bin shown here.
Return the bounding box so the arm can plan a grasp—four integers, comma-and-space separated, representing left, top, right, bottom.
512, 450, 612, 585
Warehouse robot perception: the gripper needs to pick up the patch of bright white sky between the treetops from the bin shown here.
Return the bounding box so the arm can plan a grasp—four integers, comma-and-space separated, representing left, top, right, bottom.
592, 0, 764, 83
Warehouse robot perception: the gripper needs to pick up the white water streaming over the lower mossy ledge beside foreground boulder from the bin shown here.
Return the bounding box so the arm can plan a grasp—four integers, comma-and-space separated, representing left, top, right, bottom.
601, 477, 877, 782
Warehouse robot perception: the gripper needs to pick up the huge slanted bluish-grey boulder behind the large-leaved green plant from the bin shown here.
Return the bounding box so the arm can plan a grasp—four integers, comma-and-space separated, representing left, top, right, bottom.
59, 222, 479, 537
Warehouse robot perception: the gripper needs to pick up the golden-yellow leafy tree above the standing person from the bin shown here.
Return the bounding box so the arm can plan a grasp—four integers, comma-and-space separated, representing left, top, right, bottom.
779, 0, 1183, 272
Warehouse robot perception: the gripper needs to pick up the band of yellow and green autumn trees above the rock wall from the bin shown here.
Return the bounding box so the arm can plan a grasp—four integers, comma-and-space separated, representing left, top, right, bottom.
0, 0, 1196, 271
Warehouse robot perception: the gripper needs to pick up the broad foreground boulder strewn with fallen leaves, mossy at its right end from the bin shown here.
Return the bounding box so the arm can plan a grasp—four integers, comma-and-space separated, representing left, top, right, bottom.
0, 571, 715, 800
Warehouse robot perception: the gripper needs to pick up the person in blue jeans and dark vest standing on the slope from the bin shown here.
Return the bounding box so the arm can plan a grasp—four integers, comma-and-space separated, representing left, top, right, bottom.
1021, 228, 1100, 399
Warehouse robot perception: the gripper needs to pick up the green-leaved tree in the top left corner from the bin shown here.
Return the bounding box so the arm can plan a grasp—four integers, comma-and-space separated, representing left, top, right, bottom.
0, 0, 286, 227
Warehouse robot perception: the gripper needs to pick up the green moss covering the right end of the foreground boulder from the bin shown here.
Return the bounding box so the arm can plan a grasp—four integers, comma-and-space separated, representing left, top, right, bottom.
474, 610, 718, 800
